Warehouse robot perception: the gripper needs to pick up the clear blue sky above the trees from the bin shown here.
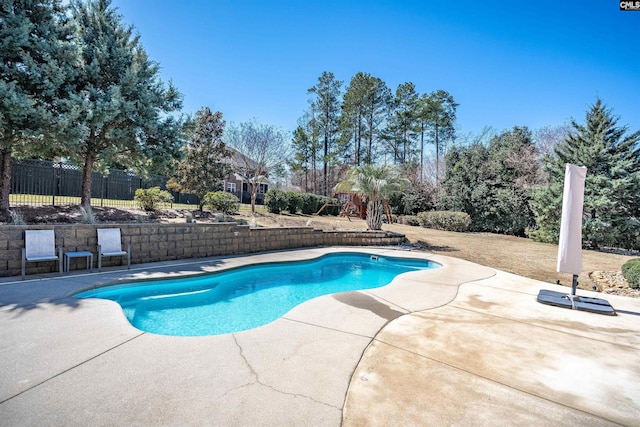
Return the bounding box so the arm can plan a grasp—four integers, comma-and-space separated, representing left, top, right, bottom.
112, 0, 640, 139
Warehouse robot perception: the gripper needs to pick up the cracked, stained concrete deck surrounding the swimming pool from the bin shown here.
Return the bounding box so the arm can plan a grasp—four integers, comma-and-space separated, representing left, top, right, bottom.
0, 247, 640, 426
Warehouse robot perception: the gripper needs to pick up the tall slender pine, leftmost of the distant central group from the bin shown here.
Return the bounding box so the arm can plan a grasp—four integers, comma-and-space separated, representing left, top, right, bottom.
308, 71, 342, 196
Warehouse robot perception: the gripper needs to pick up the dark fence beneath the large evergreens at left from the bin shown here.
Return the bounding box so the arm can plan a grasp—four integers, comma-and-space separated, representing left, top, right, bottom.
10, 160, 198, 207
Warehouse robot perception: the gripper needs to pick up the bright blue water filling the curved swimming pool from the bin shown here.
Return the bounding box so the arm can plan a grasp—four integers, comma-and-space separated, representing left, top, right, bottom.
75, 253, 439, 336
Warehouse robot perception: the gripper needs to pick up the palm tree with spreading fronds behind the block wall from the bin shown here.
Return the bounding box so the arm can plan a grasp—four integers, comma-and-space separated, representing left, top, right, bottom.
336, 165, 409, 230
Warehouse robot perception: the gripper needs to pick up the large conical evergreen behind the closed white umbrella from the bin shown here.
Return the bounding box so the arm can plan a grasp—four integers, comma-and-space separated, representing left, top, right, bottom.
530, 99, 640, 249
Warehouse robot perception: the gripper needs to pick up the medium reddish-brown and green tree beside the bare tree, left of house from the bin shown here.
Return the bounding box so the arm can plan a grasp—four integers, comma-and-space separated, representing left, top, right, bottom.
168, 107, 231, 210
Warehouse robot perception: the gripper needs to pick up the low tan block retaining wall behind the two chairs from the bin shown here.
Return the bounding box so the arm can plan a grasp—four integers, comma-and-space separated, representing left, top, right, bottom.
0, 223, 405, 276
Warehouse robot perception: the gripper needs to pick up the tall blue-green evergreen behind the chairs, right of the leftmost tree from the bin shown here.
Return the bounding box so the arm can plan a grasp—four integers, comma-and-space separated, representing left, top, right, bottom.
66, 0, 182, 206
